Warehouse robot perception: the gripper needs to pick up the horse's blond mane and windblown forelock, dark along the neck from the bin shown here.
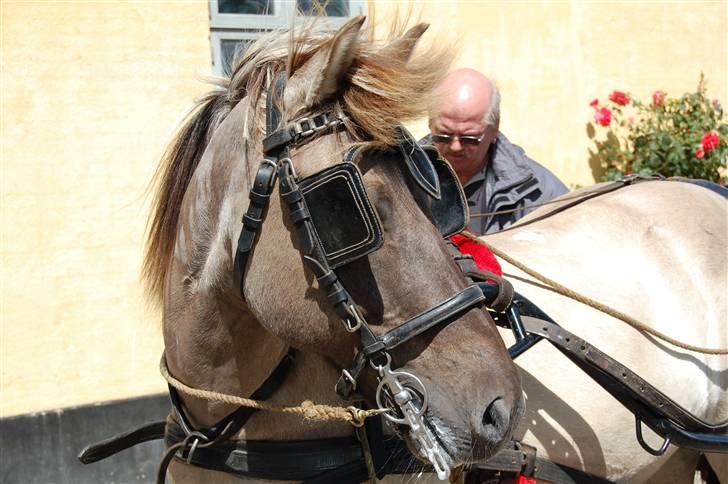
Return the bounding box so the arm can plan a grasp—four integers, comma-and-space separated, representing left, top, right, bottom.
142, 22, 452, 302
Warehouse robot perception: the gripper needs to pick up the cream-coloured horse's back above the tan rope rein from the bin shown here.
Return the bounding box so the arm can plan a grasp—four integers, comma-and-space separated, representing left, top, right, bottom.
492, 182, 728, 347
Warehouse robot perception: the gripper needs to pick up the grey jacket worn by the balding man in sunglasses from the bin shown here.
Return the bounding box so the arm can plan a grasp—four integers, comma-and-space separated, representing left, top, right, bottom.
420, 133, 569, 235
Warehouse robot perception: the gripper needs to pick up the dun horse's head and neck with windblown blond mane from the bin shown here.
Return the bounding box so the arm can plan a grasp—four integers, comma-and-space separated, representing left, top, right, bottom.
145, 18, 522, 482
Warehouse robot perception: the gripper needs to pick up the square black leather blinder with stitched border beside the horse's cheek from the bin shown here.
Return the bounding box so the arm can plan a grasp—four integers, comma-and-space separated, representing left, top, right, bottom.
298, 162, 384, 269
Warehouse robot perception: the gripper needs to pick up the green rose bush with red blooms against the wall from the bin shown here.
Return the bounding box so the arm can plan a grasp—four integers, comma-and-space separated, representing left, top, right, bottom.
589, 75, 728, 183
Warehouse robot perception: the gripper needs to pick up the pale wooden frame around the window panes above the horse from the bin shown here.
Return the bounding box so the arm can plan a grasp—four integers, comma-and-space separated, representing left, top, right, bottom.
209, 0, 366, 76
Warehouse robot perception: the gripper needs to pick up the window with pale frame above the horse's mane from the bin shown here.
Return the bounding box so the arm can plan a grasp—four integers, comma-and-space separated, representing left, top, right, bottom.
210, 0, 365, 75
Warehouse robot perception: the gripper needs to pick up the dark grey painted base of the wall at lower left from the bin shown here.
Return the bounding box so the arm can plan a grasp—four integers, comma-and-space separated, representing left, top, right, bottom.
0, 394, 170, 484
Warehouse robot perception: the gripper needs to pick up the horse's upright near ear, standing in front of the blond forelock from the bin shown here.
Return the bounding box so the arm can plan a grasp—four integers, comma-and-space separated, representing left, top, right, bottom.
284, 15, 366, 108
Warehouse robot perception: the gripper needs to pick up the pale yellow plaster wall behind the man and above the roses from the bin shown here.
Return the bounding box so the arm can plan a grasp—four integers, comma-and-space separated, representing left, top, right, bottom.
384, 0, 728, 186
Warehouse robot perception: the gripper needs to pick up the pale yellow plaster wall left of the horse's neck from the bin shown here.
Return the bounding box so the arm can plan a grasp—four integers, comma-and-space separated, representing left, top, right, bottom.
0, 1, 211, 416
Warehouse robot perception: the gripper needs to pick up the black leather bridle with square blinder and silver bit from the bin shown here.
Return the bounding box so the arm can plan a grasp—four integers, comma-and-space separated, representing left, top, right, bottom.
234, 73, 485, 479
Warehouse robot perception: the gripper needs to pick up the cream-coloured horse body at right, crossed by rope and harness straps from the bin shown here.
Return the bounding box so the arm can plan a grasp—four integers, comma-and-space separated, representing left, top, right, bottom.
484, 182, 728, 480
